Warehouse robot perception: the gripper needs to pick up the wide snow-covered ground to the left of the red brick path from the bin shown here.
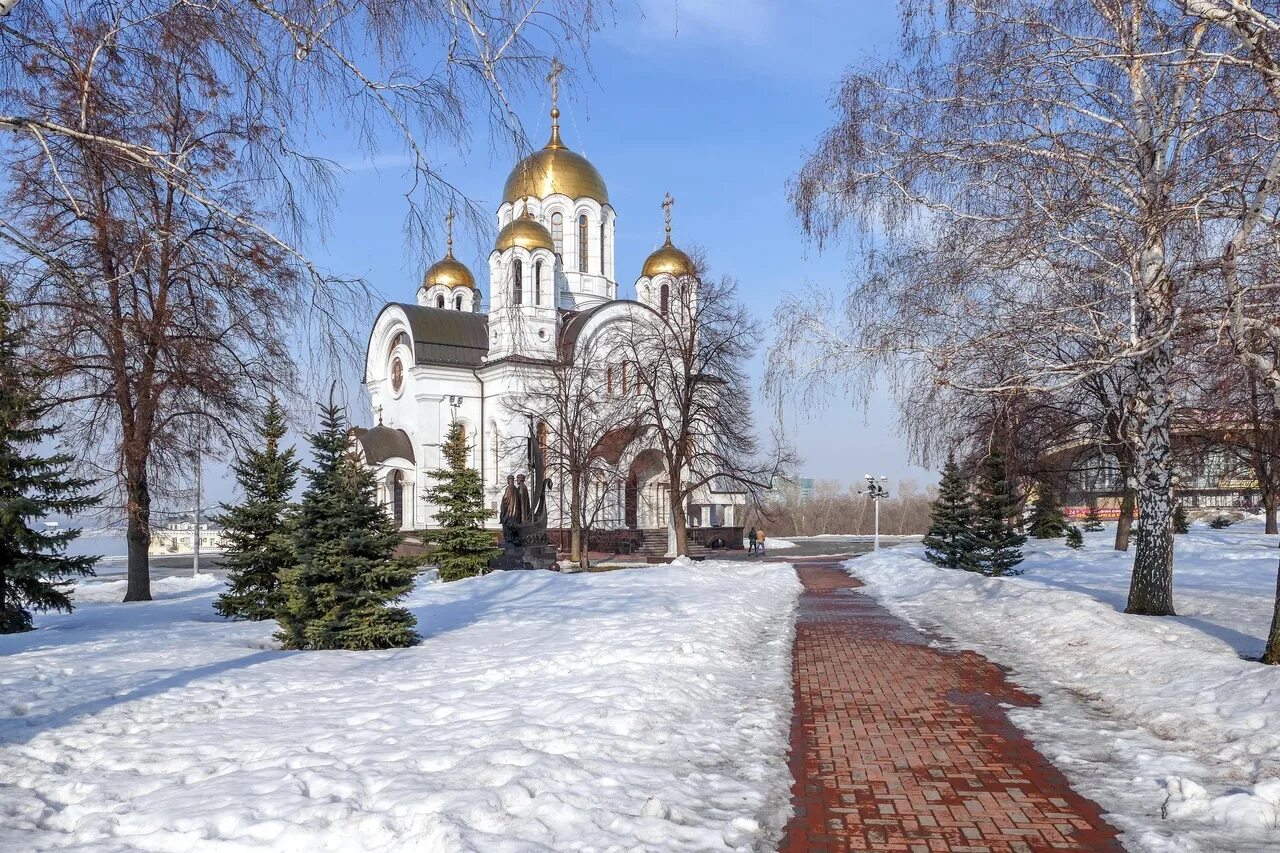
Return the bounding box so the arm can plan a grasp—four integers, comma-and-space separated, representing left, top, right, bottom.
0, 561, 799, 852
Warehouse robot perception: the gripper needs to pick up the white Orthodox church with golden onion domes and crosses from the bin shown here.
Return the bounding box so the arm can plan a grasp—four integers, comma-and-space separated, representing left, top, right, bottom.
355, 108, 745, 553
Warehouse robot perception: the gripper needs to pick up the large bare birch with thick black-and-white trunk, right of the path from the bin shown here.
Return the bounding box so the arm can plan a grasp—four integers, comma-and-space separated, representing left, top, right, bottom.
774, 0, 1216, 615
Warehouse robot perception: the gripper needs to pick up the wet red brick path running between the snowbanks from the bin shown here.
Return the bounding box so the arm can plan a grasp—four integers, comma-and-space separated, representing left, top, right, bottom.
782, 561, 1124, 853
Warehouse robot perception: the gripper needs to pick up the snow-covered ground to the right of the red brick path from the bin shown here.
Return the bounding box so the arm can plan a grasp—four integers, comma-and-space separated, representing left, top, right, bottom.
846, 520, 1280, 853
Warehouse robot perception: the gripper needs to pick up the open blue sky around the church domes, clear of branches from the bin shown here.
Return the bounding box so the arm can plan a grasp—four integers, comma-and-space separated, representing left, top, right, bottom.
264, 0, 936, 499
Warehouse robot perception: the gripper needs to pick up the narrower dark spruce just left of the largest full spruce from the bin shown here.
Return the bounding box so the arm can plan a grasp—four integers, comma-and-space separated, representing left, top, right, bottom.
214, 397, 298, 620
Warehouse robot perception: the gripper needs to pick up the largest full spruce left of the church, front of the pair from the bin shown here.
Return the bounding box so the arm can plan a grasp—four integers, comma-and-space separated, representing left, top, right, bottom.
276, 398, 417, 649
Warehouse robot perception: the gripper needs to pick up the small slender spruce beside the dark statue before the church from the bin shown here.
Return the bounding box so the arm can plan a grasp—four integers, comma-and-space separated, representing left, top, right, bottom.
426, 421, 502, 580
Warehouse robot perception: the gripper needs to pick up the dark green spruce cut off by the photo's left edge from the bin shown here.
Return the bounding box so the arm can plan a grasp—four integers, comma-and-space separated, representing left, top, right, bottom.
0, 295, 99, 634
